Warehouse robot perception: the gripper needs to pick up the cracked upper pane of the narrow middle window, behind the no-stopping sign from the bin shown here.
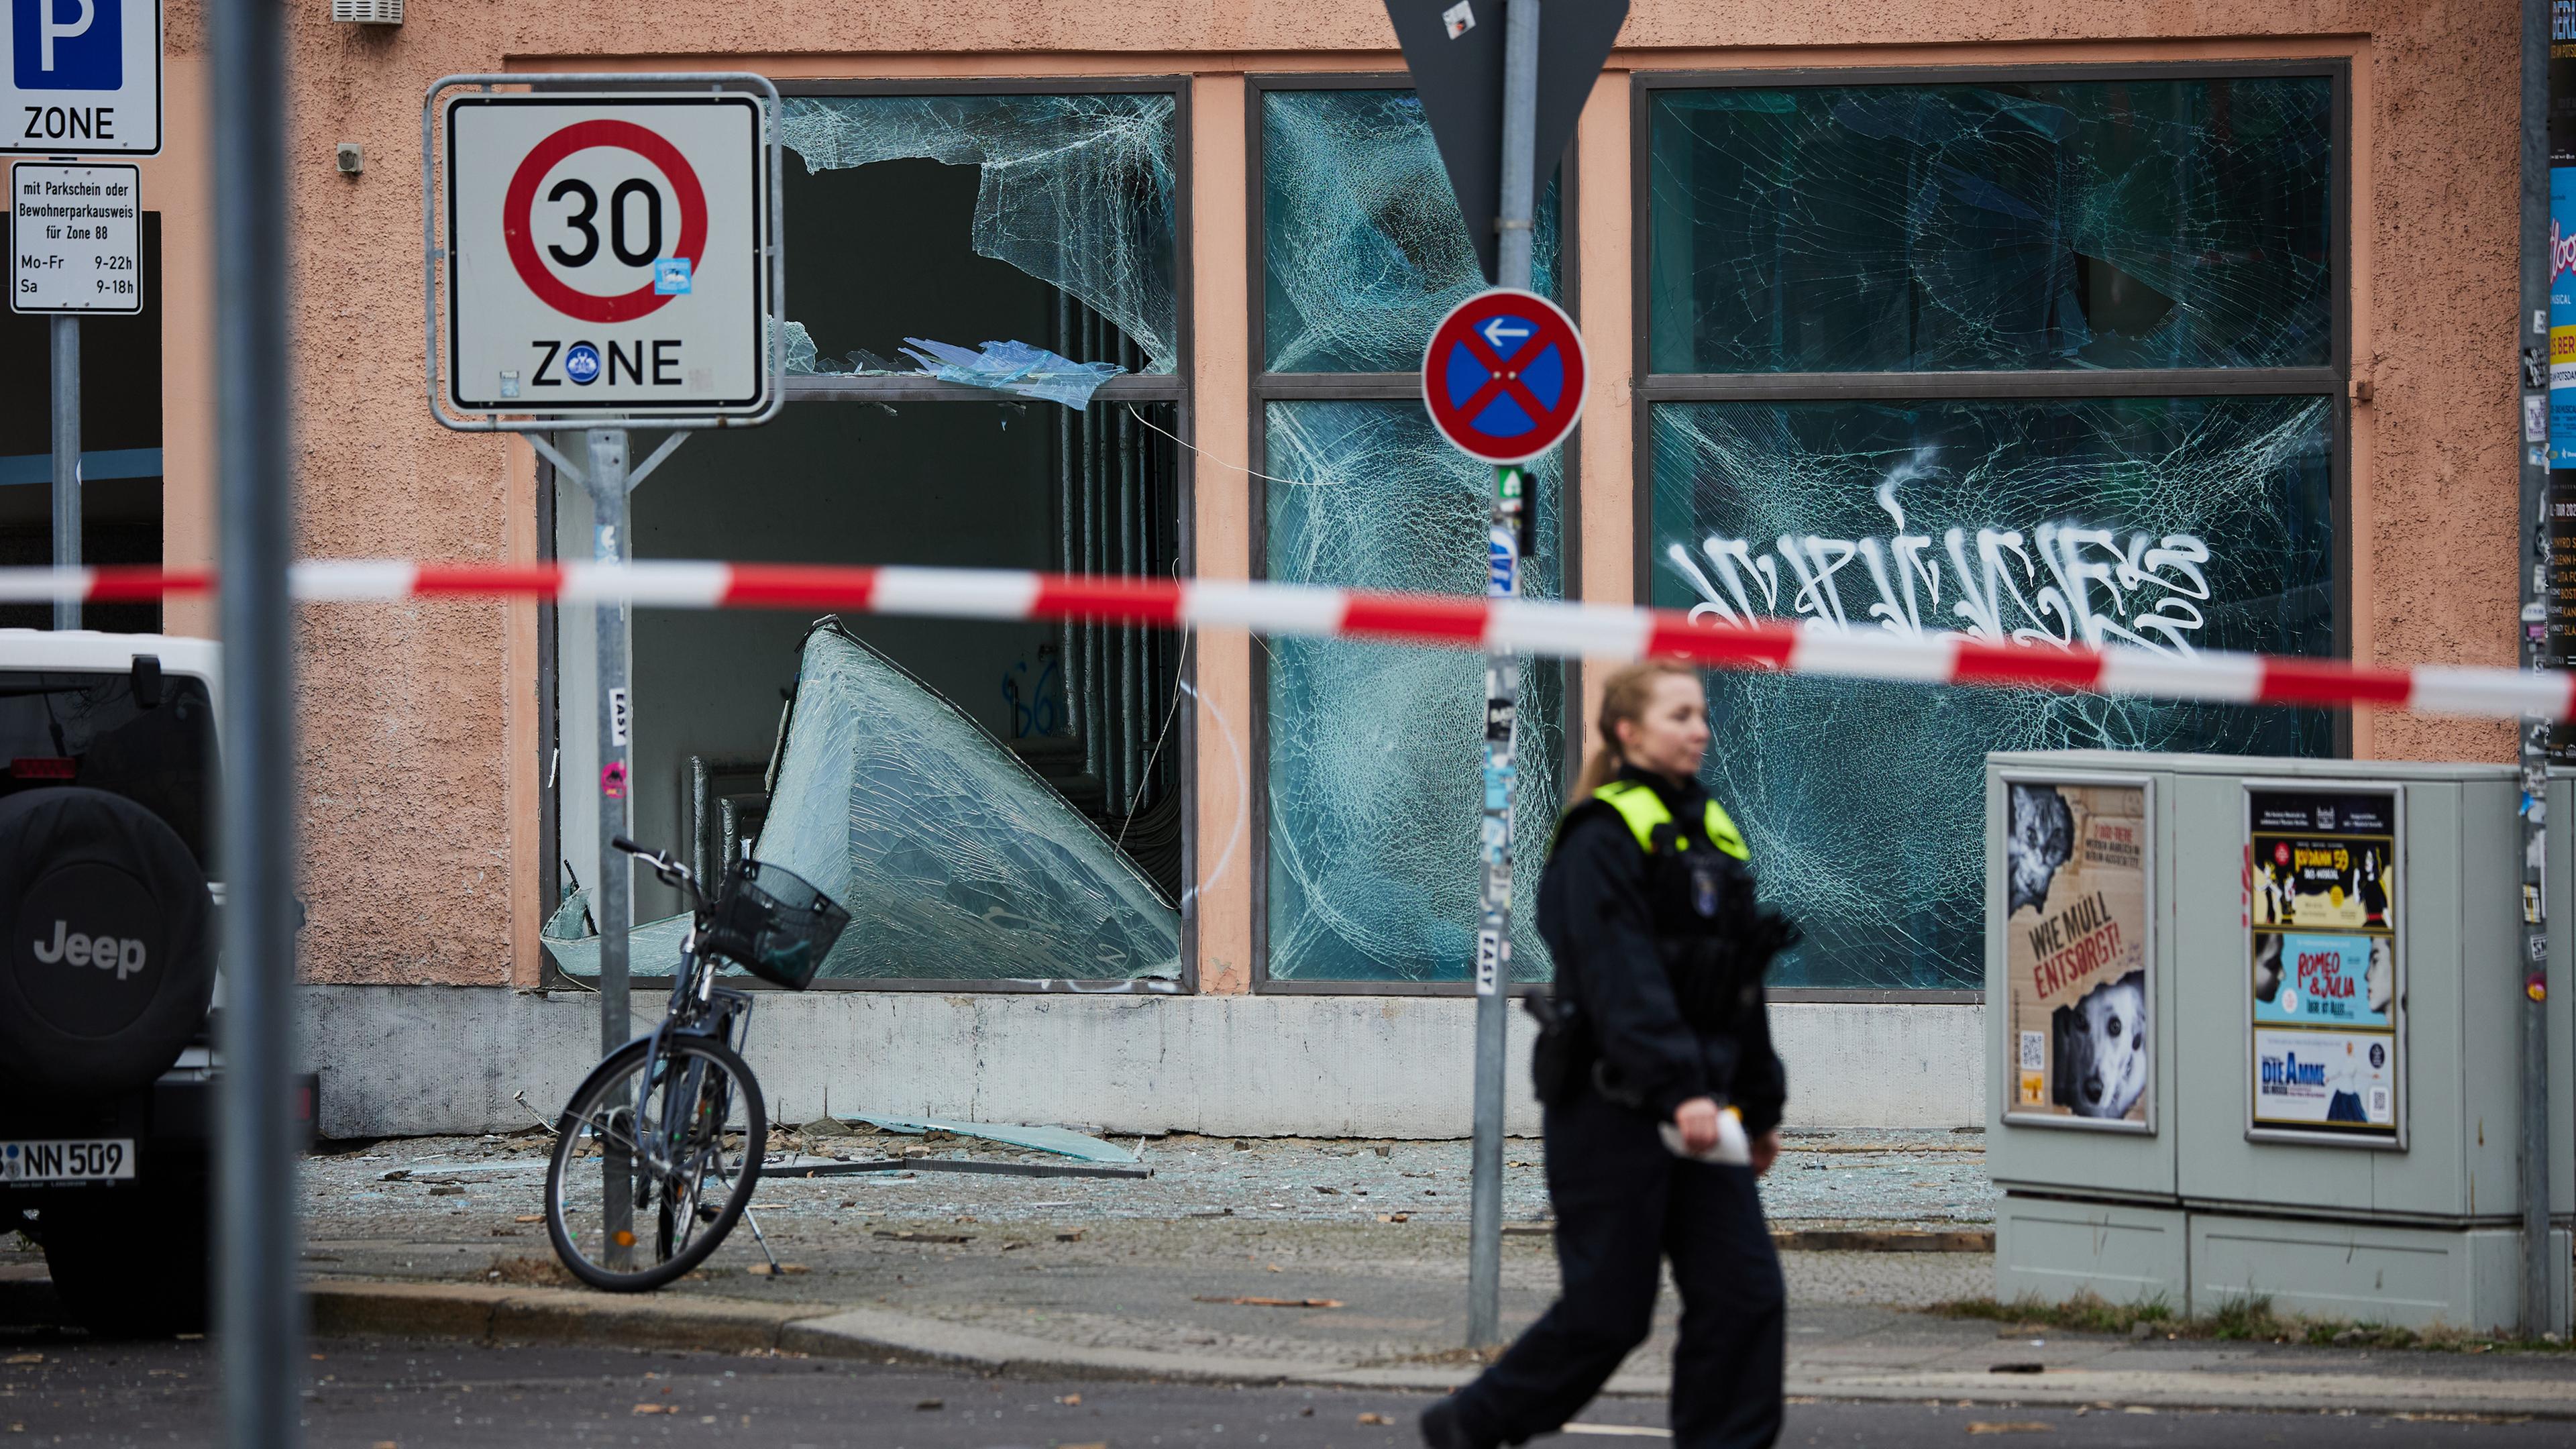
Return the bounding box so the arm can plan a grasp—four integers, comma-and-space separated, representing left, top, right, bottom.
1263, 91, 1558, 371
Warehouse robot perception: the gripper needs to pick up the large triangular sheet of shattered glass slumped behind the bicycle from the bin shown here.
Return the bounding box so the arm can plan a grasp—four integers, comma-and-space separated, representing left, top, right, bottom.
546, 621, 1180, 979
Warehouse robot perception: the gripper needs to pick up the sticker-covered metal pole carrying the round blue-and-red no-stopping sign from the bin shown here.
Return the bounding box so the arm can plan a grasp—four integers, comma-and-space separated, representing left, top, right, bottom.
1466, 0, 1538, 1348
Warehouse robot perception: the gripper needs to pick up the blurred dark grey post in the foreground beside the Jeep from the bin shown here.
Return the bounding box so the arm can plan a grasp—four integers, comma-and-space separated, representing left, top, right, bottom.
206, 0, 304, 1449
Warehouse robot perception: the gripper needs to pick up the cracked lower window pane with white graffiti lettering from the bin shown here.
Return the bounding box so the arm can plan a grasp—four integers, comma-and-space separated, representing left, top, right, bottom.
1651, 397, 2337, 987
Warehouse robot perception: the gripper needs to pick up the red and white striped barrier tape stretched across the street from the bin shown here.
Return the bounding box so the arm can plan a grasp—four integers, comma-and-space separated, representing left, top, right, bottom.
0, 559, 2576, 719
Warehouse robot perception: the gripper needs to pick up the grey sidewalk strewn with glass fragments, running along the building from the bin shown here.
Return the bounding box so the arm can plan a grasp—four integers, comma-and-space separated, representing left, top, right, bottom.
20, 1132, 2576, 1418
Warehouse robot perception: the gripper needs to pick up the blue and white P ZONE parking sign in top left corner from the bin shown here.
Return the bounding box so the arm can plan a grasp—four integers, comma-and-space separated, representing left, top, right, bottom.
0, 0, 162, 157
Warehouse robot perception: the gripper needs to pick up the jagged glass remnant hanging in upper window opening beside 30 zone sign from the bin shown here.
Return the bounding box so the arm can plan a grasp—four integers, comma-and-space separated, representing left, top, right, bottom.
781, 95, 1180, 371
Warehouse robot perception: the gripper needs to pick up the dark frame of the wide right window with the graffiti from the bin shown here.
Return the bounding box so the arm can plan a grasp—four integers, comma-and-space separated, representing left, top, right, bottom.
1628, 54, 2357, 1006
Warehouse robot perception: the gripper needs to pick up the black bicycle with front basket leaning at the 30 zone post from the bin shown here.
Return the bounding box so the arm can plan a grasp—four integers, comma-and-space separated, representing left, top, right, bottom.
546, 835, 850, 1292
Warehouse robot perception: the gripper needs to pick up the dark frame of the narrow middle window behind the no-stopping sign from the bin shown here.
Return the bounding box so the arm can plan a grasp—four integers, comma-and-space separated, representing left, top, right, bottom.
1244, 70, 1585, 996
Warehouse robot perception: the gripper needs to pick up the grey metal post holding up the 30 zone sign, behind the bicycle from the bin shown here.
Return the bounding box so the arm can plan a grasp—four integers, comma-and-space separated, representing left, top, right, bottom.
585, 428, 634, 1266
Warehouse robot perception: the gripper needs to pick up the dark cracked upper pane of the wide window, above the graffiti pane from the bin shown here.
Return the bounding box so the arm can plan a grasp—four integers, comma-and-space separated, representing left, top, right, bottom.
1649, 74, 2334, 371
